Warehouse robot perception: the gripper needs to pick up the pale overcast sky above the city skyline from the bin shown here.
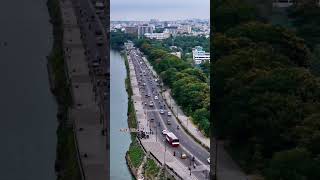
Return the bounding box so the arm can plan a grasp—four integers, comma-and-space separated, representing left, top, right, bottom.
110, 0, 210, 21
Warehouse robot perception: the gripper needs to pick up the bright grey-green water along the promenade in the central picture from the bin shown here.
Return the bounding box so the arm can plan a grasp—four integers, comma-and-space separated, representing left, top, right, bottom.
110, 50, 132, 180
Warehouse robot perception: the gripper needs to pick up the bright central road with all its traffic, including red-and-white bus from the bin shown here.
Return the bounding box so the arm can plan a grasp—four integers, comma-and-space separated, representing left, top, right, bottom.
127, 48, 210, 179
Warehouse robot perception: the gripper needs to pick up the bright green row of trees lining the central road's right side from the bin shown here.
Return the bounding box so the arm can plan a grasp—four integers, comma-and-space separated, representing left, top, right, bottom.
137, 40, 211, 136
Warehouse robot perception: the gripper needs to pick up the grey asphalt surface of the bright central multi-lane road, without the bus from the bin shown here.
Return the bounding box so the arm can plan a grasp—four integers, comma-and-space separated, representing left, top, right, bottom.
128, 49, 210, 179
